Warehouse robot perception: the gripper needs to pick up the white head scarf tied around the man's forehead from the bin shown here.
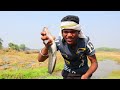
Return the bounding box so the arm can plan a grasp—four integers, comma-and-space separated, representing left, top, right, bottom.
59, 21, 86, 39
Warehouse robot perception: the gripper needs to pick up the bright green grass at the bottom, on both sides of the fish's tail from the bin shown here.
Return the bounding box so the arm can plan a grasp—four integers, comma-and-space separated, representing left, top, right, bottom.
0, 63, 63, 79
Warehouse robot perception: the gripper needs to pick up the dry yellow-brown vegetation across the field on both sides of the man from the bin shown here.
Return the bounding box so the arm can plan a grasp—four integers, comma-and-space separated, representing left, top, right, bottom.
0, 50, 120, 70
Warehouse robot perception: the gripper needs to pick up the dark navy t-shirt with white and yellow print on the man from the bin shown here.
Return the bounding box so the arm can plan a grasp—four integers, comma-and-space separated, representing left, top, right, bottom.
55, 37, 95, 76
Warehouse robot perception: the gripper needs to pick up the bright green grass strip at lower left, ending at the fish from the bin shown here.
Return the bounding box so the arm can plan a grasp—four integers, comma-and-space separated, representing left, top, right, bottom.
0, 67, 48, 79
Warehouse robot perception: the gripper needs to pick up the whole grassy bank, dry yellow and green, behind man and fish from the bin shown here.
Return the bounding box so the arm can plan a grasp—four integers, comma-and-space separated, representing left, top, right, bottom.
0, 50, 120, 79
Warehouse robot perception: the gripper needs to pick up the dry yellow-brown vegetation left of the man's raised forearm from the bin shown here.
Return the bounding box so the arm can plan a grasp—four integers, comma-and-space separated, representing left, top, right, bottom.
0, 50, 40, 70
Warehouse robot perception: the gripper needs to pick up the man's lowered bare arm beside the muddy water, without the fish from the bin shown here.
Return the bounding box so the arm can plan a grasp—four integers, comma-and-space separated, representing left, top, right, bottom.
81, 54, 98, 79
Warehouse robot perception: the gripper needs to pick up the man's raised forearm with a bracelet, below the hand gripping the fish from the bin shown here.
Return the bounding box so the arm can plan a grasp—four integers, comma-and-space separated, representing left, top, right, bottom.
38, 47, 48, 62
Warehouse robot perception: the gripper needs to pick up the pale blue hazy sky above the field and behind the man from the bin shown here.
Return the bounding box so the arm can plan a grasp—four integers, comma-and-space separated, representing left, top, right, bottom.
0, 11, 120, 49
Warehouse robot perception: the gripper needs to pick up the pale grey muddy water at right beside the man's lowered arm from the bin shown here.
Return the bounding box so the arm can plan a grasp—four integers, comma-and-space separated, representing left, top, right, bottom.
91, 60, 120, 79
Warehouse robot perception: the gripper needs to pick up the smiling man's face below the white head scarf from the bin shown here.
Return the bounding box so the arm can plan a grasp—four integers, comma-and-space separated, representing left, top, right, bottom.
62, 29, 79, 45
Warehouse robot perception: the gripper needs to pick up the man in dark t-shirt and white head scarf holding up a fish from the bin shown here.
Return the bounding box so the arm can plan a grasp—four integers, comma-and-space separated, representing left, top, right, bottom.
38, 15, 98, 79
